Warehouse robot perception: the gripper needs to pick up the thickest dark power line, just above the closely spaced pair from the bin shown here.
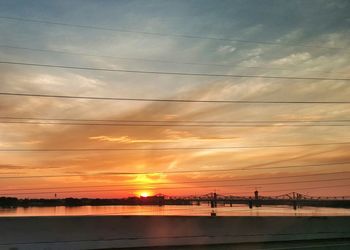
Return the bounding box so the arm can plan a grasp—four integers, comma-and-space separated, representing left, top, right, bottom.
0, 92, 350, 104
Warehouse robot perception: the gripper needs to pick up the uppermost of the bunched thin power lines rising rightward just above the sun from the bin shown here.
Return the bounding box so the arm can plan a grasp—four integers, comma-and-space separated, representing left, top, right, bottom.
1, 171, 350, 191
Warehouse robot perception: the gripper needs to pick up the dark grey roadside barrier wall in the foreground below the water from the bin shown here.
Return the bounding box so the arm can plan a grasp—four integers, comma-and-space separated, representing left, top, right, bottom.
0, 216, 350, 250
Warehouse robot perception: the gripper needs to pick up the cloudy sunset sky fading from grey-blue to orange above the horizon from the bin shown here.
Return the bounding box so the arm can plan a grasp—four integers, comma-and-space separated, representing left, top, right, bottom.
0, 0, 350, 198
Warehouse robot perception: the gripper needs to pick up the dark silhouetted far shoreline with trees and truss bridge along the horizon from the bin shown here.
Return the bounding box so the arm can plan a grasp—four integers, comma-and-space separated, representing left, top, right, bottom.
0, 190, 350, 209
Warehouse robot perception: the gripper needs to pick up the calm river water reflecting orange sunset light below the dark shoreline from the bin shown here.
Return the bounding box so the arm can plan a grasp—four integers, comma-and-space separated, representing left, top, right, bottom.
0, 205, 350, 217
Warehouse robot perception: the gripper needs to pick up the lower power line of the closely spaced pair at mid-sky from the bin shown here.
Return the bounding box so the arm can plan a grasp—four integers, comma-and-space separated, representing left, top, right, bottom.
0, 121, 350, 128
